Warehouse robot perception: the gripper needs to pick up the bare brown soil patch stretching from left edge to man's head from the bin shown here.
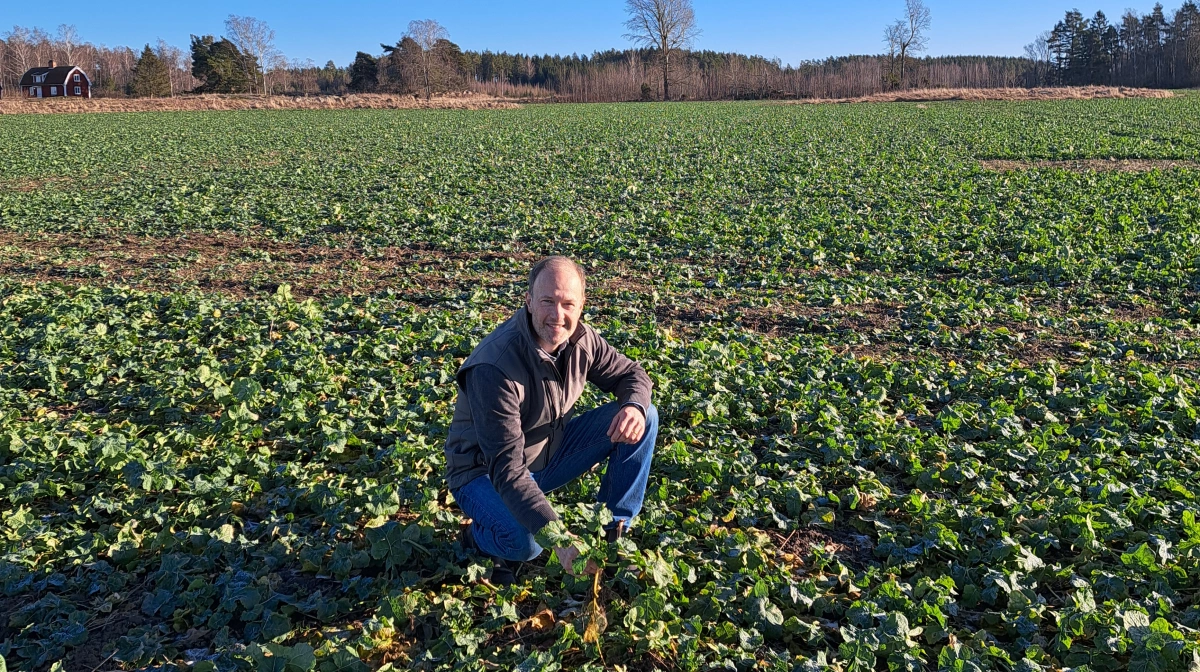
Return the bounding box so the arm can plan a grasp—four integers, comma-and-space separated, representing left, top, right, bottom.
0, 232, 533, 298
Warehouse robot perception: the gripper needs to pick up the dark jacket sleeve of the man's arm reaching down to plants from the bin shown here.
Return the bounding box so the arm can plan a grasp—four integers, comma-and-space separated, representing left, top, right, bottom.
463, 364, 558, 533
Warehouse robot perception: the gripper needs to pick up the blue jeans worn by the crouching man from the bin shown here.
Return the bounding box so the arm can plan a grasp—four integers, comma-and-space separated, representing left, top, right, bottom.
454, 402, 659, 562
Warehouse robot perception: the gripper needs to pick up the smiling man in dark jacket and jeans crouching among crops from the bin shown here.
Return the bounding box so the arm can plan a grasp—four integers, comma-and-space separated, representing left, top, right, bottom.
445, 257, 658, 583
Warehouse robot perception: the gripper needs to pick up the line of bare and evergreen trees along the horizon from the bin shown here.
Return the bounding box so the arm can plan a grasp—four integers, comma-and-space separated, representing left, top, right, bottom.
0, 0, 1200, 102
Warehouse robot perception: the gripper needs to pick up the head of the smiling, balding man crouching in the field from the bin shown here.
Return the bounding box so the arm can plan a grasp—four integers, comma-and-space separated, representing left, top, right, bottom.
526, 257, 584, 353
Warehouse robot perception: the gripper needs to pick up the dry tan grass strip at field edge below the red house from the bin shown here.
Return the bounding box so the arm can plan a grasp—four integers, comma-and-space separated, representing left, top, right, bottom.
0, 92, 518, 114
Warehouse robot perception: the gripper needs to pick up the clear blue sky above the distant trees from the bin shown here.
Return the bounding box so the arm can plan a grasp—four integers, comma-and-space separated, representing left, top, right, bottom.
0, 0, 1182, 65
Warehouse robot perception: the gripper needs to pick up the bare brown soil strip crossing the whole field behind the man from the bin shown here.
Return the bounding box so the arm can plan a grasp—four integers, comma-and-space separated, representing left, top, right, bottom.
0, 232, 1180, 364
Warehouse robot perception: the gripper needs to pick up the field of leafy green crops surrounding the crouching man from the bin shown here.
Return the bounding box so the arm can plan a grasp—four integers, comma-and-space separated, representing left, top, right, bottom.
0, 95, 1200, 672
